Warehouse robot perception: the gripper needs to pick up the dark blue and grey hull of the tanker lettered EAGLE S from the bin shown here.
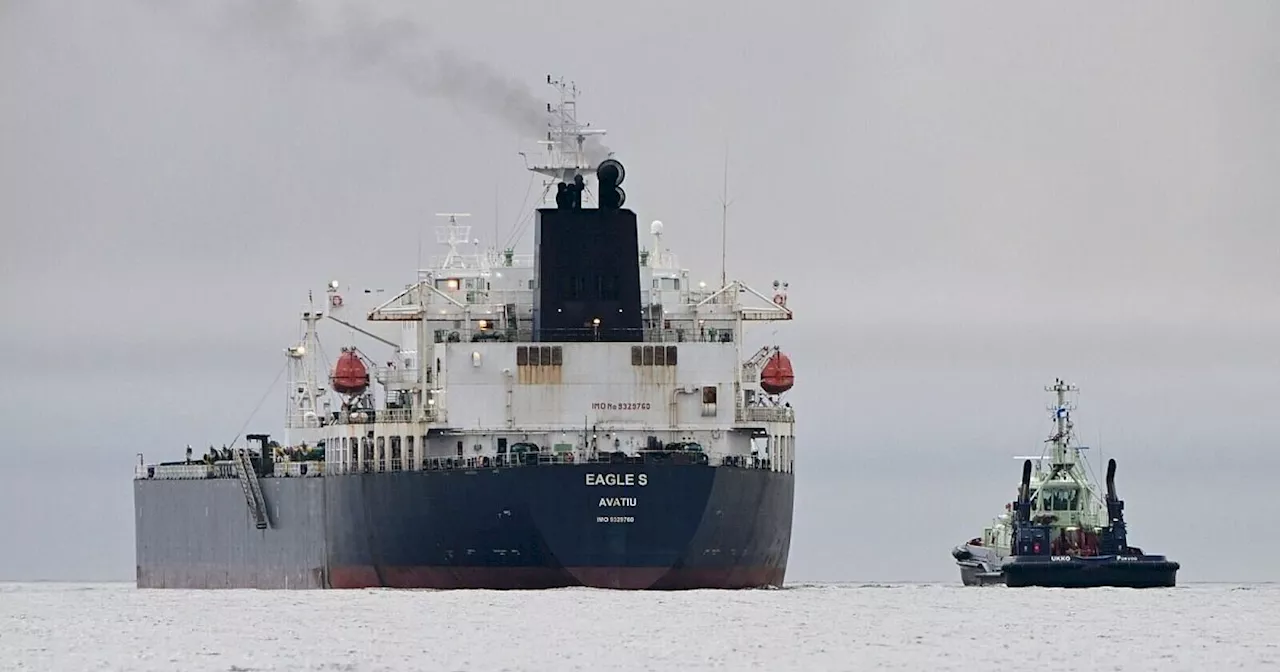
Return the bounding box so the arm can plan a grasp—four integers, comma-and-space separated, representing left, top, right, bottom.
134, 463, 794, 589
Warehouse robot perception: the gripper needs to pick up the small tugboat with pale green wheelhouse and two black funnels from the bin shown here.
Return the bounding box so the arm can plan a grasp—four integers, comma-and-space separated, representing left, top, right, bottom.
951, 379, 1179, 588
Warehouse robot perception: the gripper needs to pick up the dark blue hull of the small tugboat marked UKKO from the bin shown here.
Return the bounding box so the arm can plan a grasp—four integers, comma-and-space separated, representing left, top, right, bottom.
1002, 556, 1179, 588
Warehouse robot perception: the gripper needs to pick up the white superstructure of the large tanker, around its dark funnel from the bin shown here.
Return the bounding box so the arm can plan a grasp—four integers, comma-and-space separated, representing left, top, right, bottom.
277, 78, 795, 474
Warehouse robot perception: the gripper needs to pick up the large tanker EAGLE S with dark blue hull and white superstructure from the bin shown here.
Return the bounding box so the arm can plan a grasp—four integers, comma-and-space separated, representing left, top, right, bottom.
133, 77, 795, 589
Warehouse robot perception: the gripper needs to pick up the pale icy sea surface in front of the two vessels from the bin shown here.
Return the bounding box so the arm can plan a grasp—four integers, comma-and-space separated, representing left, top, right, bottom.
0, 584, 1280, 672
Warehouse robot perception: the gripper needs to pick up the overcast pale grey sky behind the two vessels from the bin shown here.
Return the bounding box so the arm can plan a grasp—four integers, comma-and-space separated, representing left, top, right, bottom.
0, 0, 1280, 580
